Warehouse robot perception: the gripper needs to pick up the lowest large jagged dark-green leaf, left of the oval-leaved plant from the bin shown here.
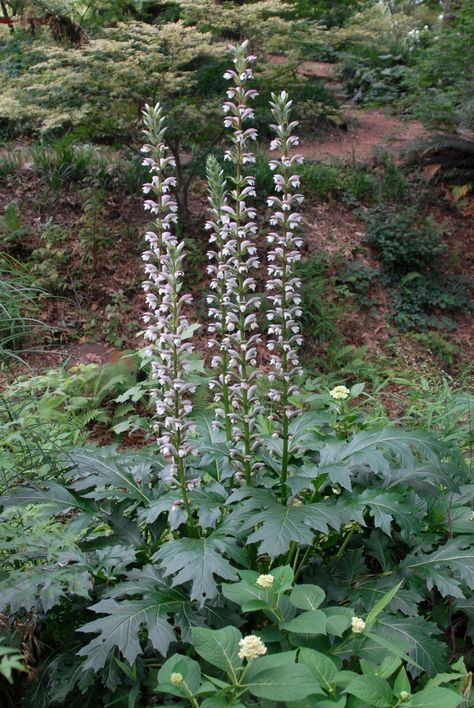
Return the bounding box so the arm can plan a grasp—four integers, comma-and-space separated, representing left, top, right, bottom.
79, 583, 188, 671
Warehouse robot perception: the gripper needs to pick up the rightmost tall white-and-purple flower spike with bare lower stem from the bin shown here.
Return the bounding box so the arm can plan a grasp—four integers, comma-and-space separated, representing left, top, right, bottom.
267, 91, 303, 502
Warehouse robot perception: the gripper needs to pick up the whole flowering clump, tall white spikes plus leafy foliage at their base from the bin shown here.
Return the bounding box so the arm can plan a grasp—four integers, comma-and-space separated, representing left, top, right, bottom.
0, 42, 474, 708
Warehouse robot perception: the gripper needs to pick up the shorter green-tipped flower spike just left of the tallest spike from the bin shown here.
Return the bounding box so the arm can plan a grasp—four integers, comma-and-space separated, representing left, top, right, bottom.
206, 155, 232, 441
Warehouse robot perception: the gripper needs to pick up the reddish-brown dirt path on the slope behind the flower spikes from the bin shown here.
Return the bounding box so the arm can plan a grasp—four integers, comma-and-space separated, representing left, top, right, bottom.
272, 56, 428, 162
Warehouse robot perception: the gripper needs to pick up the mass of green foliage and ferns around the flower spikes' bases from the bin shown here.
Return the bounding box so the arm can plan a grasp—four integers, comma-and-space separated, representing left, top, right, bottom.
0, 365, 472, 708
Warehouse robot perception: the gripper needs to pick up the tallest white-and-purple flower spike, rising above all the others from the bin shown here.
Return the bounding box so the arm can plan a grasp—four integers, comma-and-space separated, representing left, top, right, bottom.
222, 42, 261, 484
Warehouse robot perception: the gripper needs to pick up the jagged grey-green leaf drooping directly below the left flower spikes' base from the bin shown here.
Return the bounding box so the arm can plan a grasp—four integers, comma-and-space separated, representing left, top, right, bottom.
153, 536, 237, 605
